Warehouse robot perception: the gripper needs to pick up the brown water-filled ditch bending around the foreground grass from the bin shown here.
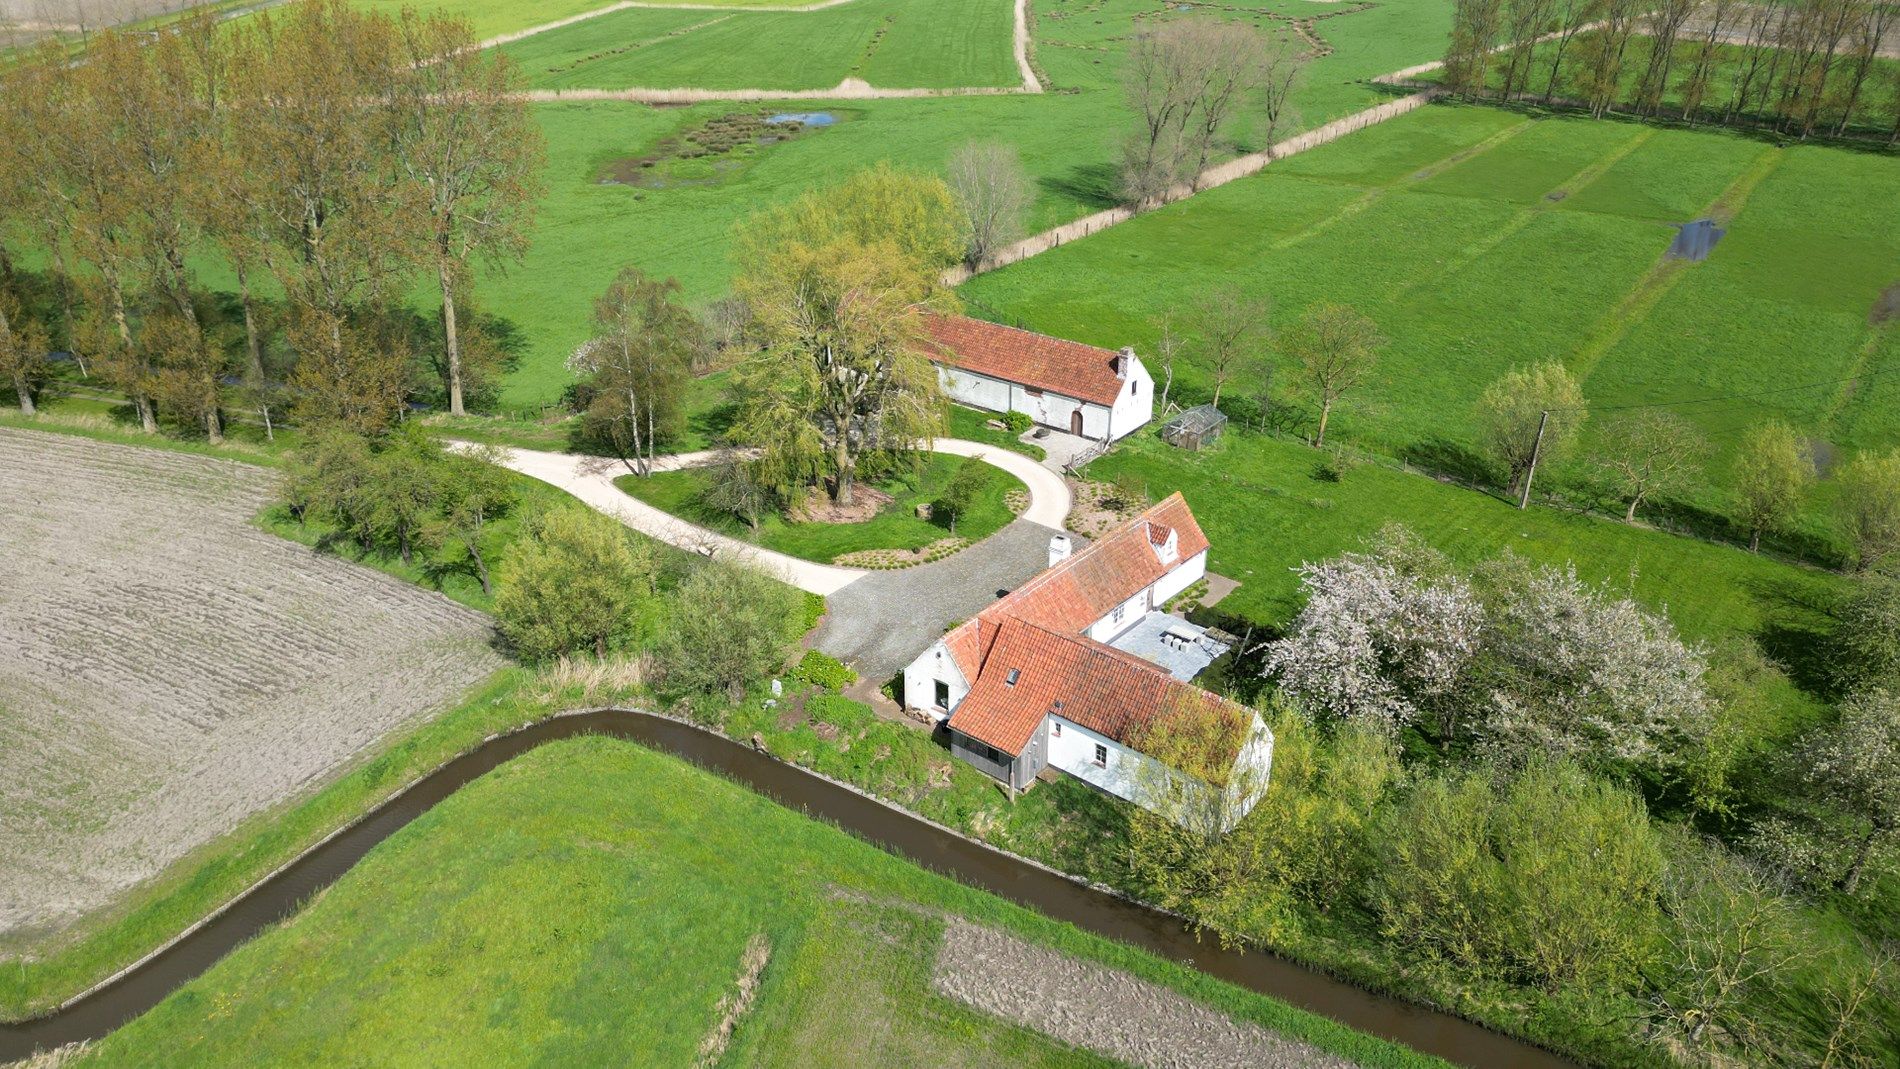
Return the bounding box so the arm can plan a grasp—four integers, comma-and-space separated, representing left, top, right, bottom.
0, 710, 1575, 1069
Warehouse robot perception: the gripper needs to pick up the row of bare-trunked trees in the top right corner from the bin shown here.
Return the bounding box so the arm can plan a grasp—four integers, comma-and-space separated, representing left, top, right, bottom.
1444, 0, 1900, 142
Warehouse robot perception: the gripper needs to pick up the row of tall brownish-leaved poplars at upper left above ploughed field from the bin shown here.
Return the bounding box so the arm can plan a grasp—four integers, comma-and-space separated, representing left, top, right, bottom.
0, 0, 543, 441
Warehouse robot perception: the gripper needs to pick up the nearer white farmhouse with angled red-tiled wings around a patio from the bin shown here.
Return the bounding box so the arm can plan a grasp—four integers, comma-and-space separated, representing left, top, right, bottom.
904, 494, 1273, 832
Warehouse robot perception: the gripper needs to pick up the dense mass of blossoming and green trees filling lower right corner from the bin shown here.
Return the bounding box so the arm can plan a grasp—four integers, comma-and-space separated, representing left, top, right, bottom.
1127, 526, 1900, 1065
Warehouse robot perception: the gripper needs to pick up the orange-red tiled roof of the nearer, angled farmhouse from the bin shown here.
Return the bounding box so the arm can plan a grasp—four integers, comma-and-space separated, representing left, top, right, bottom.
944, 494, 1239, 754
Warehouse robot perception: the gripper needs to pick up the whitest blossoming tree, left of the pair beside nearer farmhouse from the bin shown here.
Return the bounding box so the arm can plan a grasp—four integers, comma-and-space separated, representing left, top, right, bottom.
1265, 539, 1484, 731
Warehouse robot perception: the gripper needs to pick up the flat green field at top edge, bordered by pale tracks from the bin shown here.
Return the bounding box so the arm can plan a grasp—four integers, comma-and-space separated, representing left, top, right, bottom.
502, 0, 1022, 89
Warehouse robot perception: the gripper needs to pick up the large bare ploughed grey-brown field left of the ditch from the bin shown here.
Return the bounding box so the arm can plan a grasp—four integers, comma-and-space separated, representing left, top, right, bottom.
0, 429, 502, 949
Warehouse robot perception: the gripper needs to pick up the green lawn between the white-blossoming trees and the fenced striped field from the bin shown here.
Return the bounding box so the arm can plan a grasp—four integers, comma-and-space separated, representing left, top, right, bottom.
1085, 433, 1845, 750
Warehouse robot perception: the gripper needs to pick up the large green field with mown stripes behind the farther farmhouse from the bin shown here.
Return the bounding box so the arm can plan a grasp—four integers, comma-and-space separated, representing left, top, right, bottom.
963, 104, 1900, 539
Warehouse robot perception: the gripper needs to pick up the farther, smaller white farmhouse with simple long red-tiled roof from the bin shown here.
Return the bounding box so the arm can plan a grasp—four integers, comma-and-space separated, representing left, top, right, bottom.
925, 315, 1155, 442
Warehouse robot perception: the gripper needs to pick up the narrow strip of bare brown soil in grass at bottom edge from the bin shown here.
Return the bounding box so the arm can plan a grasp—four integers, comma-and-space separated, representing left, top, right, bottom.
931, 921, 1353, 1069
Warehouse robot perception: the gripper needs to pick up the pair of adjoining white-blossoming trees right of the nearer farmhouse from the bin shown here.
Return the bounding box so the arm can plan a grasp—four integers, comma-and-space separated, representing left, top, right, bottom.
1265, 532, 1714, 765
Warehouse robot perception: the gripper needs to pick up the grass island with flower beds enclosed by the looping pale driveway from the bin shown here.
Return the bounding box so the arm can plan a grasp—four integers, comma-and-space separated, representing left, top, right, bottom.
614, 454, 1022, 564
